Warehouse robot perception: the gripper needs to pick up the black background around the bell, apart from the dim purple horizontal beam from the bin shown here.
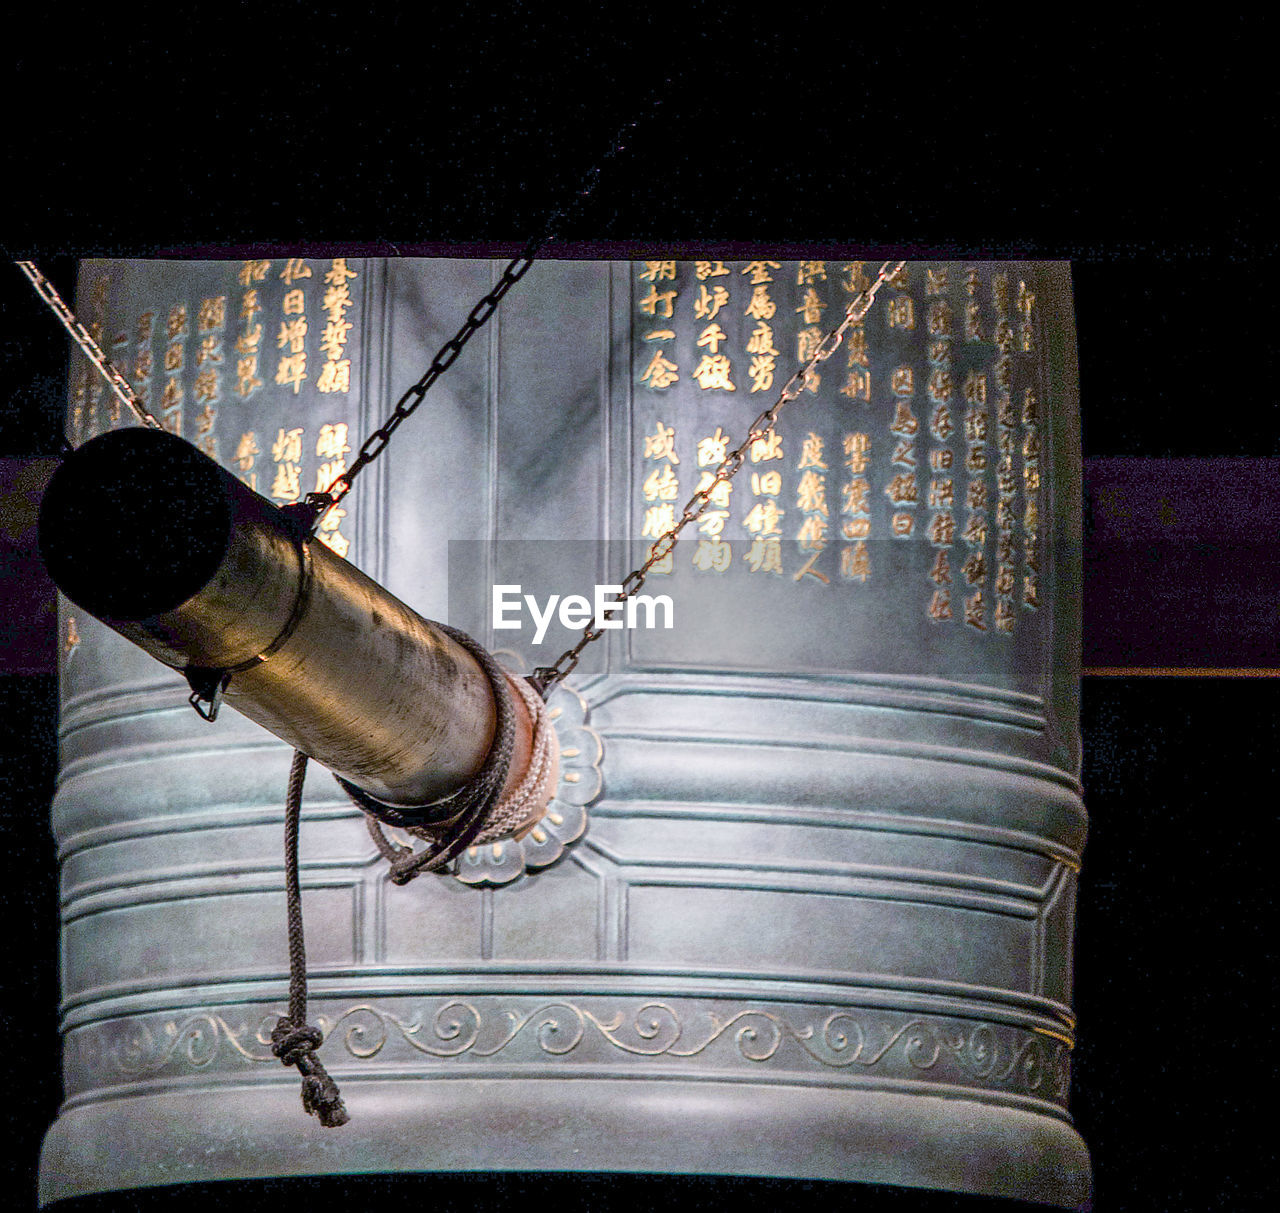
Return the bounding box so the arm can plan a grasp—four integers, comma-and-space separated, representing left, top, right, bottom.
0, 11, 1280, 1210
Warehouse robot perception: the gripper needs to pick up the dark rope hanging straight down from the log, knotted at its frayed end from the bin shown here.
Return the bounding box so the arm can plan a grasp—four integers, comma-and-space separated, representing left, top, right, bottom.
271, 750, 351, 1129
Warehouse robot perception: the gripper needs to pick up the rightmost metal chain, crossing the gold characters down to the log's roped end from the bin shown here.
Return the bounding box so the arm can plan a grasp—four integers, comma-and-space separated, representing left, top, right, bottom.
531, 261, 906, 697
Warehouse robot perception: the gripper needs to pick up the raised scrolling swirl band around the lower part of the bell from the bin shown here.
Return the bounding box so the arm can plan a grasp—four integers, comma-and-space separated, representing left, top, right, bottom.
85, 998, 1070, 1102
